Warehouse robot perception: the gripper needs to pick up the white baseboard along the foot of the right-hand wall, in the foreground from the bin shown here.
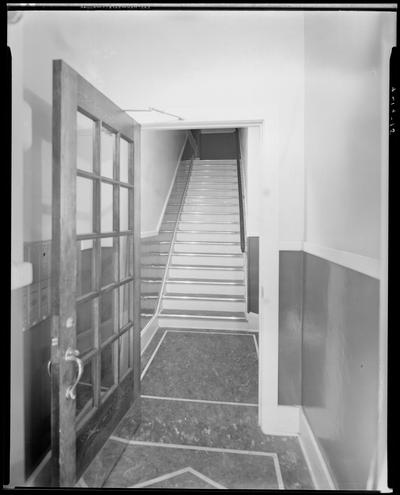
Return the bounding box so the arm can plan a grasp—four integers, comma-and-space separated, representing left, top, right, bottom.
299, 407, 337, 490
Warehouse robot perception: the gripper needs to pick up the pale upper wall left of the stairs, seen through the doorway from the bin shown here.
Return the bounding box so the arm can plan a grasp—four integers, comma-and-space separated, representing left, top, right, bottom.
140, 130, 186, 235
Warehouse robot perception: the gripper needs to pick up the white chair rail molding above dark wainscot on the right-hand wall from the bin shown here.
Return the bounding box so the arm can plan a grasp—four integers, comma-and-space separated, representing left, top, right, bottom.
304, 242, 380, 279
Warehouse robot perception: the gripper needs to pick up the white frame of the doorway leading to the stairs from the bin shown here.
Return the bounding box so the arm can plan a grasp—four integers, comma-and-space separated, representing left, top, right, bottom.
139, 116, 299, 435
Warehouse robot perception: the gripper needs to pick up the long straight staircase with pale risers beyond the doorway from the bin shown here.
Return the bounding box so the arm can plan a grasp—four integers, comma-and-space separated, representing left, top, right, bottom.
158, 160, 250, 330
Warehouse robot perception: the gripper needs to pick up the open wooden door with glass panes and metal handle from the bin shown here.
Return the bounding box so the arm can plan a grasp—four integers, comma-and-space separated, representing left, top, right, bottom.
50, 60, 140, 486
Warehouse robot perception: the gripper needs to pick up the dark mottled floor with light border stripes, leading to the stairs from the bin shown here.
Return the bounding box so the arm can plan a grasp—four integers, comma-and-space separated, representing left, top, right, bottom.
81, 329, 313, 489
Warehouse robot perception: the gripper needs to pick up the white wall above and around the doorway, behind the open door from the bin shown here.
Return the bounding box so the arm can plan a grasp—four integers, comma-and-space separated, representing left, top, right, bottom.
18, 11, 304, 241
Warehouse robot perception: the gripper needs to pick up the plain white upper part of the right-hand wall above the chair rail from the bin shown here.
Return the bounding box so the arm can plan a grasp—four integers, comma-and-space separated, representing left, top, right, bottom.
304, 12, 395, 258
